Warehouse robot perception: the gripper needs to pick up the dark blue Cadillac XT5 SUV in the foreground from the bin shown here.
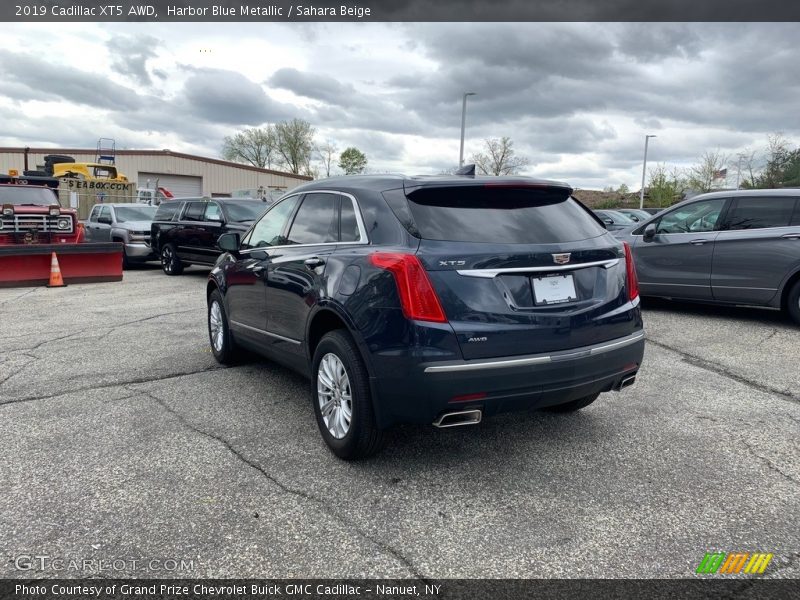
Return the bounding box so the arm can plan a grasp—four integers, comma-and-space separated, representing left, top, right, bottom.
206, 175, 644, 459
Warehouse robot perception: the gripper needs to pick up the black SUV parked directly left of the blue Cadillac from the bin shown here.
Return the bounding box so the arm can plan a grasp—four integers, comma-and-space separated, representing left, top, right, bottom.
150, 198, 267, 275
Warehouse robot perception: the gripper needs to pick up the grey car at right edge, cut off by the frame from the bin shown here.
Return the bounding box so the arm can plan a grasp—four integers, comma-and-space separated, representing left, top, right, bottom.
615, 189, 800, 323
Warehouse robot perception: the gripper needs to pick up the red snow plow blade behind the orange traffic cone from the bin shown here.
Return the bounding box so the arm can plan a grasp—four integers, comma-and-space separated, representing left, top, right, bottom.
0, 242, 122, 287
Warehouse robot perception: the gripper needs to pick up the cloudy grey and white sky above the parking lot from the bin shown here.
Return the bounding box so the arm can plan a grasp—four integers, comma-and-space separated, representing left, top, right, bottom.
0, 23, 800, 189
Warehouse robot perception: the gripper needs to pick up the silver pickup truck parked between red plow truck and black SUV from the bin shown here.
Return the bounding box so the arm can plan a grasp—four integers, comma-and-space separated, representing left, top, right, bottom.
85, 203, 158, 269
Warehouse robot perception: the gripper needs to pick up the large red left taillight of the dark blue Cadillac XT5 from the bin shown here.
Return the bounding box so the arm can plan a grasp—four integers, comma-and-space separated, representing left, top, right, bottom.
369, 252, 447, 323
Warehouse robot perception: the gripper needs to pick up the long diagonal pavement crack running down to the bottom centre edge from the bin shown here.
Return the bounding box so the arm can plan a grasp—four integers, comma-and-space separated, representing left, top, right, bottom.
132, 386, 432, 584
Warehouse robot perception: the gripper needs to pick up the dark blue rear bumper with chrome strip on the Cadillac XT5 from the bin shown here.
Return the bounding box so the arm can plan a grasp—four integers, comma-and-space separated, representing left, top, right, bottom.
372, 330, 644, 427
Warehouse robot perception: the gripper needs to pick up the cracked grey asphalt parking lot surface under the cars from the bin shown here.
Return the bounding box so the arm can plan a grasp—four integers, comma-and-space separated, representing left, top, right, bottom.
0, 266, 800, 578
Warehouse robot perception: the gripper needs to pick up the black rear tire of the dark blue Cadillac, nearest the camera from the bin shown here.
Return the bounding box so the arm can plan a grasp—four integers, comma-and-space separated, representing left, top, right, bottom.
311, 329, 385, 460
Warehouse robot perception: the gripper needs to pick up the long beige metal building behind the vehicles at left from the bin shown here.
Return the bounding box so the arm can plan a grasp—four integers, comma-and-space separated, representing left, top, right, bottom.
0, 148, 311, 196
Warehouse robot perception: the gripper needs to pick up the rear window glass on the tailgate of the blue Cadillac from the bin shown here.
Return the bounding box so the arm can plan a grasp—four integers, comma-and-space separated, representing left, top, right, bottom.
408, 187, 606, 244
